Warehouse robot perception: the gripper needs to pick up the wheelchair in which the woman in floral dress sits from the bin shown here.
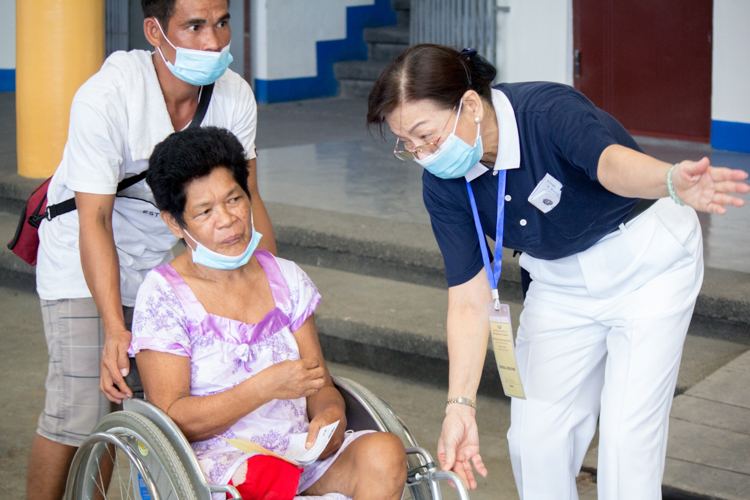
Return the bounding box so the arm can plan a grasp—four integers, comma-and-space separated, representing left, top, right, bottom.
65, 377, 469, 500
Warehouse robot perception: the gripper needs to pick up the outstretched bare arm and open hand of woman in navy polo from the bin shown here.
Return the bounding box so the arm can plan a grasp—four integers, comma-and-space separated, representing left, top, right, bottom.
597, 144, 750, 214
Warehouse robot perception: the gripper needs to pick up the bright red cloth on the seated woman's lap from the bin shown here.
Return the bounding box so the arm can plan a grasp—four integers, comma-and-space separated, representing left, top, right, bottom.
227, 455, 302, 500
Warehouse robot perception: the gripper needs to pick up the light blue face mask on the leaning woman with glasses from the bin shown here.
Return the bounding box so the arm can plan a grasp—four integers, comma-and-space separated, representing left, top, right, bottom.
415, 100, 484, 179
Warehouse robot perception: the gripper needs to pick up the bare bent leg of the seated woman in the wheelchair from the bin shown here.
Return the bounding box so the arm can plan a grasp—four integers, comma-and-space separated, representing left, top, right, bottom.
303, 432, 406, 500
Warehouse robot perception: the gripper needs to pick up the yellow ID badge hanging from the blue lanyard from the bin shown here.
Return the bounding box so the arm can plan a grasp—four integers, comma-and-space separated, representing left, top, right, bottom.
488, 302, 526, 399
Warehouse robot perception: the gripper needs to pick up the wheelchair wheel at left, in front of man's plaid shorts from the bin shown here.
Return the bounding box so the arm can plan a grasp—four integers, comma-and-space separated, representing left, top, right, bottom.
65, 411, 197, 500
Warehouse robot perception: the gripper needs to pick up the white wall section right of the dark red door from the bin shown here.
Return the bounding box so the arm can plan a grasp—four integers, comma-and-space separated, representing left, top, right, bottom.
711, 0, 750, 123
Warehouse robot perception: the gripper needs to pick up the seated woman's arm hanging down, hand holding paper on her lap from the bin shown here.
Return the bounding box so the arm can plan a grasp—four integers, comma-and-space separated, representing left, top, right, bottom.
293, 316, 346, 460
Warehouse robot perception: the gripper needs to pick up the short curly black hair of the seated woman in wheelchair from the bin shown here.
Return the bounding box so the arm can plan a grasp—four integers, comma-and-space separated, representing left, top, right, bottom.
146, 127, 250, 227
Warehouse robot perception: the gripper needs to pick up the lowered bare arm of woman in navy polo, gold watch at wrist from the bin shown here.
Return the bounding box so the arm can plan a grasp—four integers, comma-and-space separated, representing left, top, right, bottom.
438, 270, 492, 489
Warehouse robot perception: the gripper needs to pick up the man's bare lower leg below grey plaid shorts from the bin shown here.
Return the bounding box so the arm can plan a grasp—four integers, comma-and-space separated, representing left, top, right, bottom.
26, 434, 78, 500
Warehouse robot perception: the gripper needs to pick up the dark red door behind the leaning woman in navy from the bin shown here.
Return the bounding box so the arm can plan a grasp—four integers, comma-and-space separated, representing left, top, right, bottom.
573, 0, 713, 142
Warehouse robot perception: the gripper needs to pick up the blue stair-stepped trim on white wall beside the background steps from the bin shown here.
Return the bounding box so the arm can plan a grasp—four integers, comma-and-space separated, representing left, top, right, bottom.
255, 0, 397, 103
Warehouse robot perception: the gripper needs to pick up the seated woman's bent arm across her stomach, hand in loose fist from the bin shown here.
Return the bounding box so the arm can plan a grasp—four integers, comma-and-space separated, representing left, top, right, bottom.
135, 350, 324, 442
